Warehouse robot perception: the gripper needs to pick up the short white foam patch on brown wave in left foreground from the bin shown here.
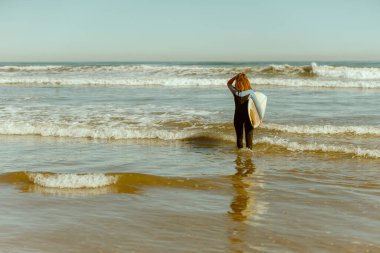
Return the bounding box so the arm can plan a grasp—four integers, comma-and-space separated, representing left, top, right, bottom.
28, 172, 118, 189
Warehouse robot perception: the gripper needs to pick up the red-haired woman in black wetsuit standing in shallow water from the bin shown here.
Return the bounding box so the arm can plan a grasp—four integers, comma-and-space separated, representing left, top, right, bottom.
227, 73, 255, 149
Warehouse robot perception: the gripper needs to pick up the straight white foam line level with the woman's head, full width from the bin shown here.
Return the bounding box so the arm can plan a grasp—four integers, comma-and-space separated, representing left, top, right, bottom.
0, 76, 380, 89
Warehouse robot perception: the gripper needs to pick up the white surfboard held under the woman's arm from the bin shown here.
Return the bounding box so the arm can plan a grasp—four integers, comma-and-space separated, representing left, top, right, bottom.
248, 91, 267, 128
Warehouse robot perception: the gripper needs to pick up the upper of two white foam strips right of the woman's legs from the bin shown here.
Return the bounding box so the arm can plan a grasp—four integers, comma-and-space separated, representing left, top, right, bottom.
261, 123, 380, 135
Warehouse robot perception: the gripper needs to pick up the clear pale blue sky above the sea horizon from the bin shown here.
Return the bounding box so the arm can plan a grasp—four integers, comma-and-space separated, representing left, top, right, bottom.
0, 0, 380, 62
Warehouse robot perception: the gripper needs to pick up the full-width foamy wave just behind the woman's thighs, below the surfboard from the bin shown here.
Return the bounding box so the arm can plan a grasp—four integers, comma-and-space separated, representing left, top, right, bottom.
0, 121, 380, 141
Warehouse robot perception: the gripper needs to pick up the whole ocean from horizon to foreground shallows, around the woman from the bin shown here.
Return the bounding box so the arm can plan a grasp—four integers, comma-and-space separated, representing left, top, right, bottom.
0, 62, 380, 253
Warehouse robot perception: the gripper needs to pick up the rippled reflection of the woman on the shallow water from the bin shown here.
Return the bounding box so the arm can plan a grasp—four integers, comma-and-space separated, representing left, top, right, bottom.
228, 152, 256, 252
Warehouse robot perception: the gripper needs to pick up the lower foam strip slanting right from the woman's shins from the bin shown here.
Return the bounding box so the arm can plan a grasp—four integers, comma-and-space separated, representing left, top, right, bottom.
255, 137, 380, 158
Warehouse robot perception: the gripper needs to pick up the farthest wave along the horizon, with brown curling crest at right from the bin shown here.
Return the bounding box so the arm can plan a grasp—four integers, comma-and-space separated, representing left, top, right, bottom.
0, 62, 380, 80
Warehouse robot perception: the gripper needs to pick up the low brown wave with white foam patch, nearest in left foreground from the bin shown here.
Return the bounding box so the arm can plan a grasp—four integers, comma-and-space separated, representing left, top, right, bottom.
0, 171, 218, 195
